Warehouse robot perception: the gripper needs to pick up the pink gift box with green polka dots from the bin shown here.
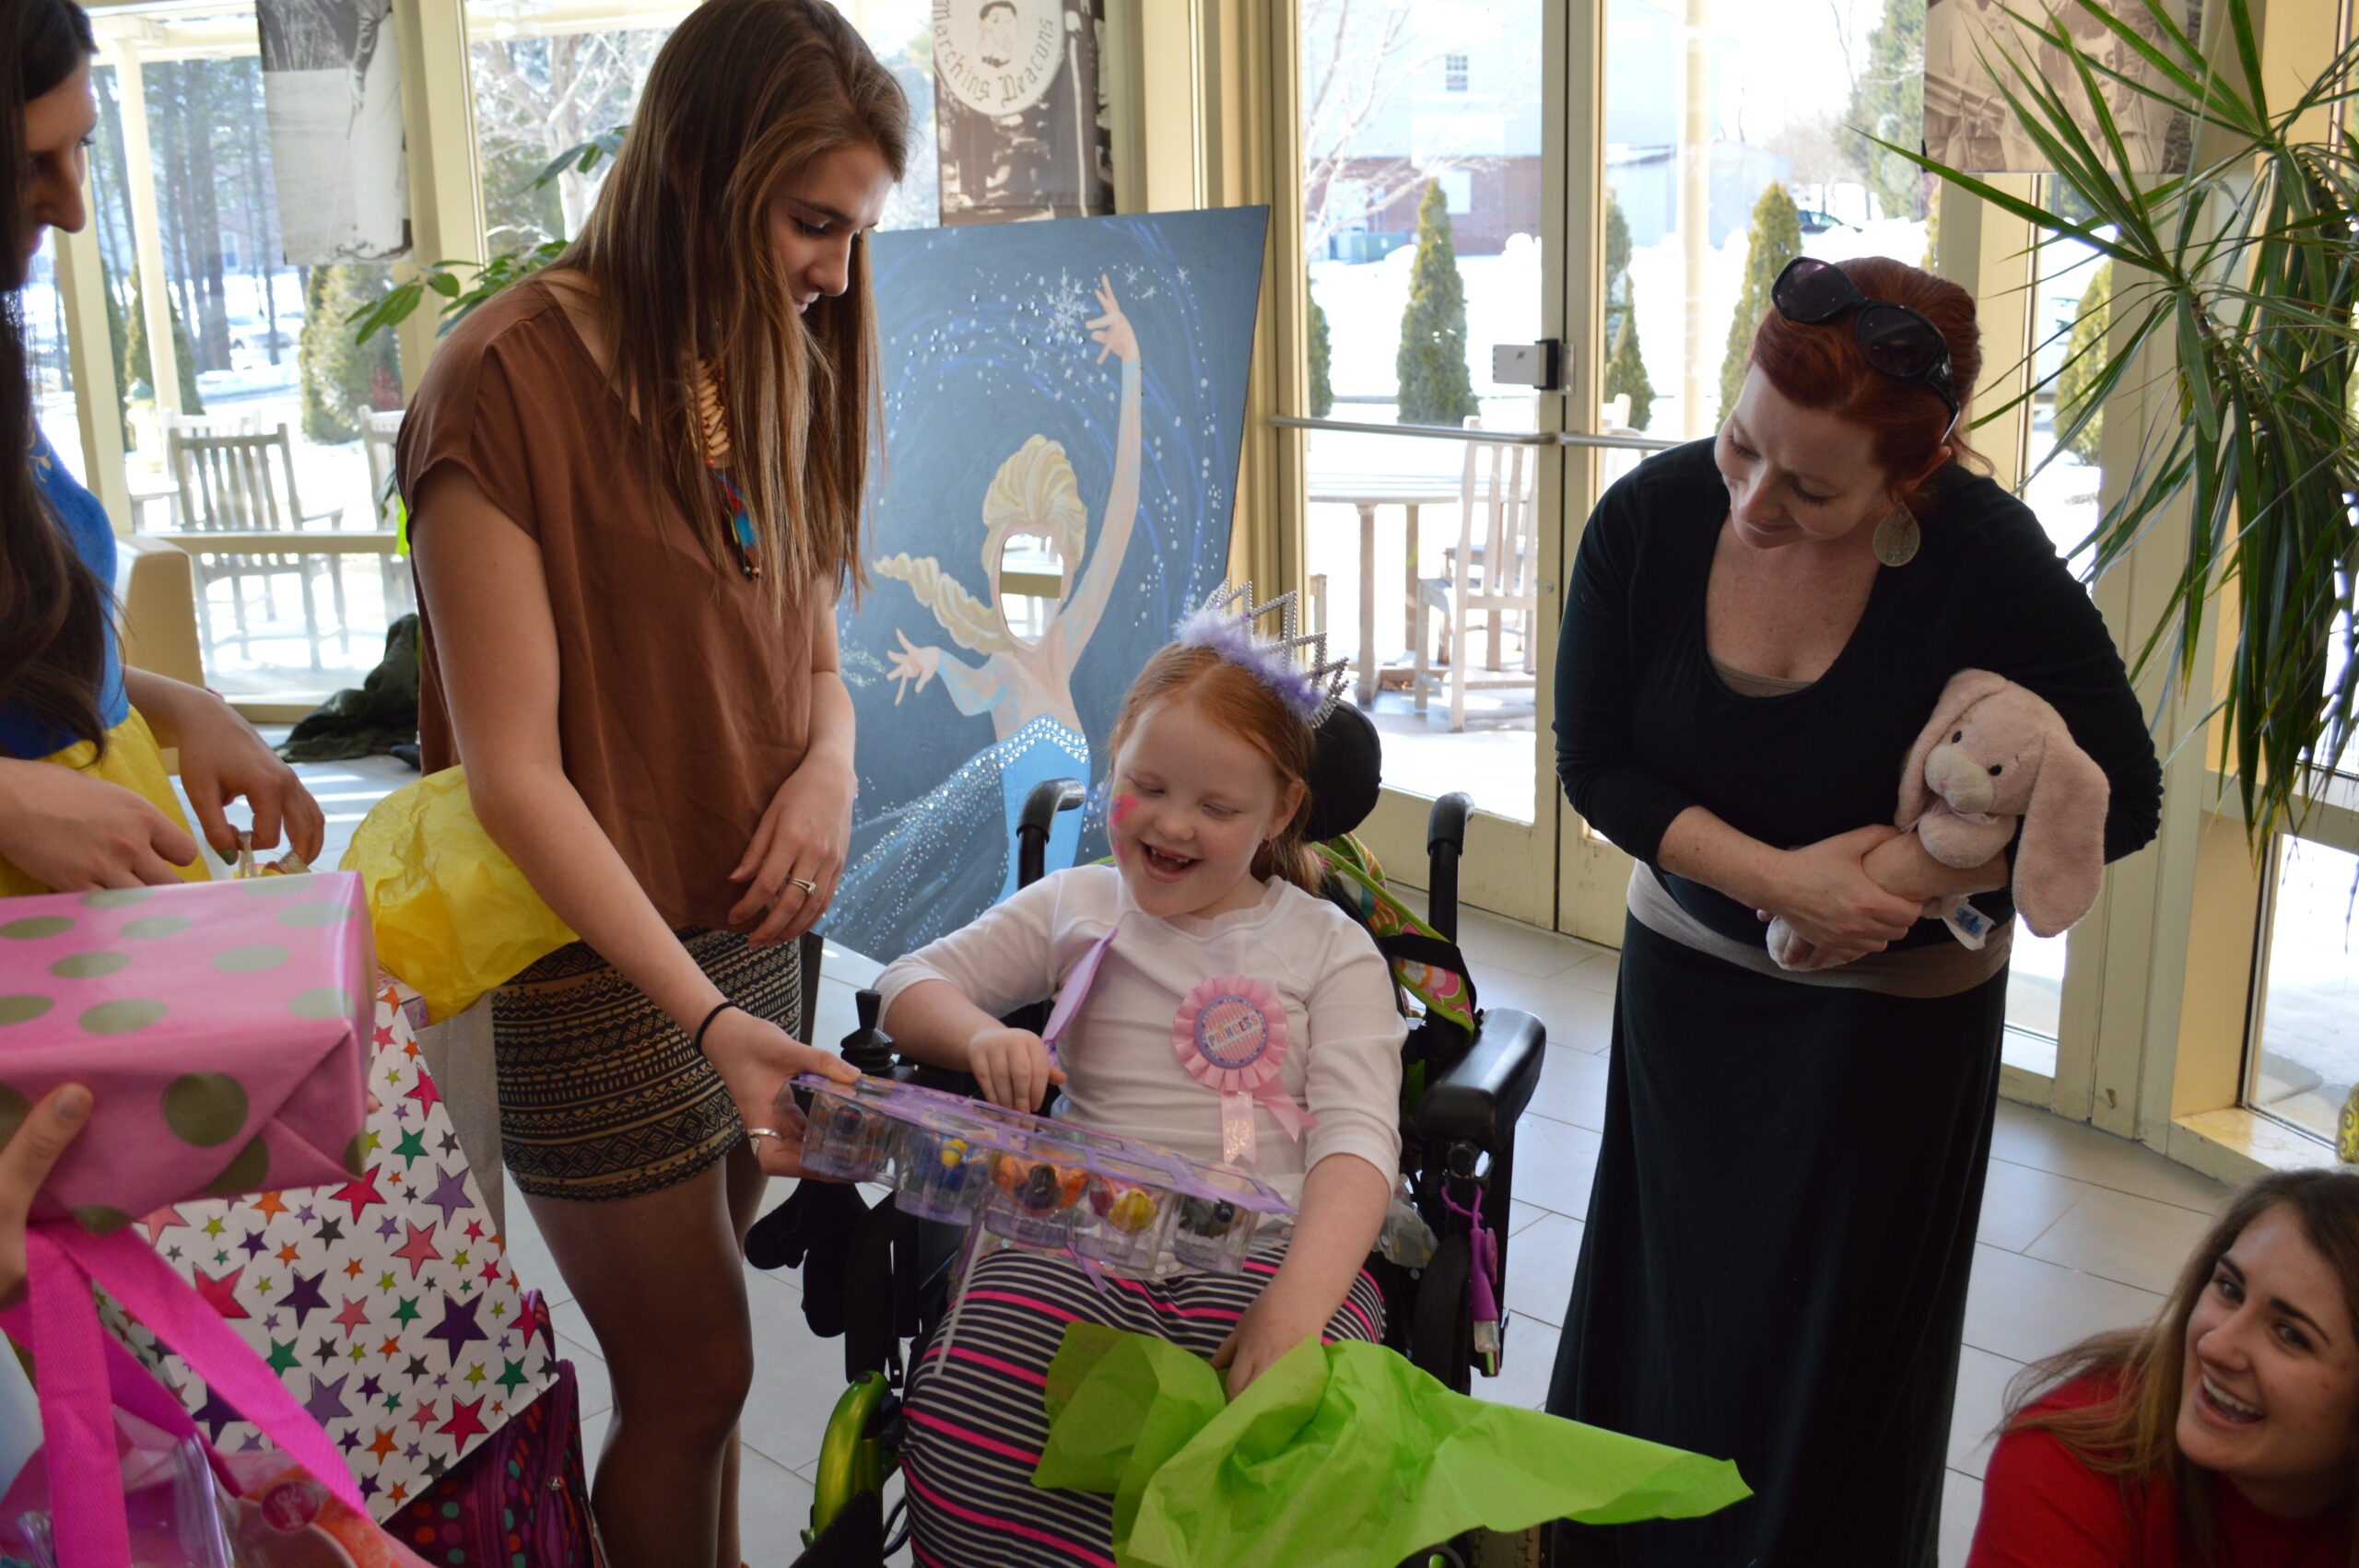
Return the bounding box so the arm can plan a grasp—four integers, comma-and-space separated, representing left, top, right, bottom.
0, 872, 375, 1231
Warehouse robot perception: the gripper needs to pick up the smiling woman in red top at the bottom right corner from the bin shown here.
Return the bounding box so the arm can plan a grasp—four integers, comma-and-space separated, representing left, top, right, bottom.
1970, 1169, 2359, 1568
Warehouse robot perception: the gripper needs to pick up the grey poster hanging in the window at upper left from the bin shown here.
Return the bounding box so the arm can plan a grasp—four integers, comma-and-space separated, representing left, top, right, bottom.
254, 0, 410, 266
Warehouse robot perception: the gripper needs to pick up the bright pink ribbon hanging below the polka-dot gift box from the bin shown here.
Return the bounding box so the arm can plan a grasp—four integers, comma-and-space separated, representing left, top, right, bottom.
0, 1219, 368, 1568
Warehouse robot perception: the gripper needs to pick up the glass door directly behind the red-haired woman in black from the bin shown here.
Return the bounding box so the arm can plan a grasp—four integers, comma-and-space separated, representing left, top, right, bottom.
1550, 0, 1932, 945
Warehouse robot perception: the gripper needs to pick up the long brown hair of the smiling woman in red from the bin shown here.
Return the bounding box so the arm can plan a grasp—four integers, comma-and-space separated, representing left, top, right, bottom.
2005, 1169, 2359, 1568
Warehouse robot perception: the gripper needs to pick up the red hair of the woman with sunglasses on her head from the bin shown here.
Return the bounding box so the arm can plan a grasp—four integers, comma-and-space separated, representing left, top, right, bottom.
1753, 257, 1989, 511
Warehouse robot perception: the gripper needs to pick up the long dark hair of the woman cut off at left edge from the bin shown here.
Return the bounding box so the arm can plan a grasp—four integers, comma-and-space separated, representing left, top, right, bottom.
0, 0, 111, 750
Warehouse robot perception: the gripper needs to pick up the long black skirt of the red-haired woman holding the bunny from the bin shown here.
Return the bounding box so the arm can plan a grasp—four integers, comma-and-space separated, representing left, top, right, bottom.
1547, 919, 2008, 1568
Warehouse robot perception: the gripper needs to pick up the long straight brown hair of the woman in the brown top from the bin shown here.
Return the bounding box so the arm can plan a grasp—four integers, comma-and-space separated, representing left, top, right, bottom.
557, 0, 909, 594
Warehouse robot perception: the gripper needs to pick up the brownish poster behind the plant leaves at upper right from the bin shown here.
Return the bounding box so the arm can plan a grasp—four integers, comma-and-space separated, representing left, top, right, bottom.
1925, 0, 2203, 174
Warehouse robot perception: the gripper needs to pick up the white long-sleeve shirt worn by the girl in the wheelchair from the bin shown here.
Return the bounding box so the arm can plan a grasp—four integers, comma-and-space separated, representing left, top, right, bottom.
877, 865, 1408, 1188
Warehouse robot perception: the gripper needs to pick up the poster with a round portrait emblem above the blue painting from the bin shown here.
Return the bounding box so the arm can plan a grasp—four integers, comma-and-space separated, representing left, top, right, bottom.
934, 0, 1113, 224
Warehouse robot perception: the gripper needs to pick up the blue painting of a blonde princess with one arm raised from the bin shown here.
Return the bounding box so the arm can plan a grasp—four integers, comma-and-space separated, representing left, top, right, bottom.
826, 207, 1269, 960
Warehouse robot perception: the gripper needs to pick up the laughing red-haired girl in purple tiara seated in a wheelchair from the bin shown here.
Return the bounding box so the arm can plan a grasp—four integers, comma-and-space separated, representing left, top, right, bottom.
877, 587, 1403, 1568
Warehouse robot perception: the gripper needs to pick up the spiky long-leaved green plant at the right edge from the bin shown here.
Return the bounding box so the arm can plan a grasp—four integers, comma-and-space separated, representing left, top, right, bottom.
1871, 0, 2359, 842
